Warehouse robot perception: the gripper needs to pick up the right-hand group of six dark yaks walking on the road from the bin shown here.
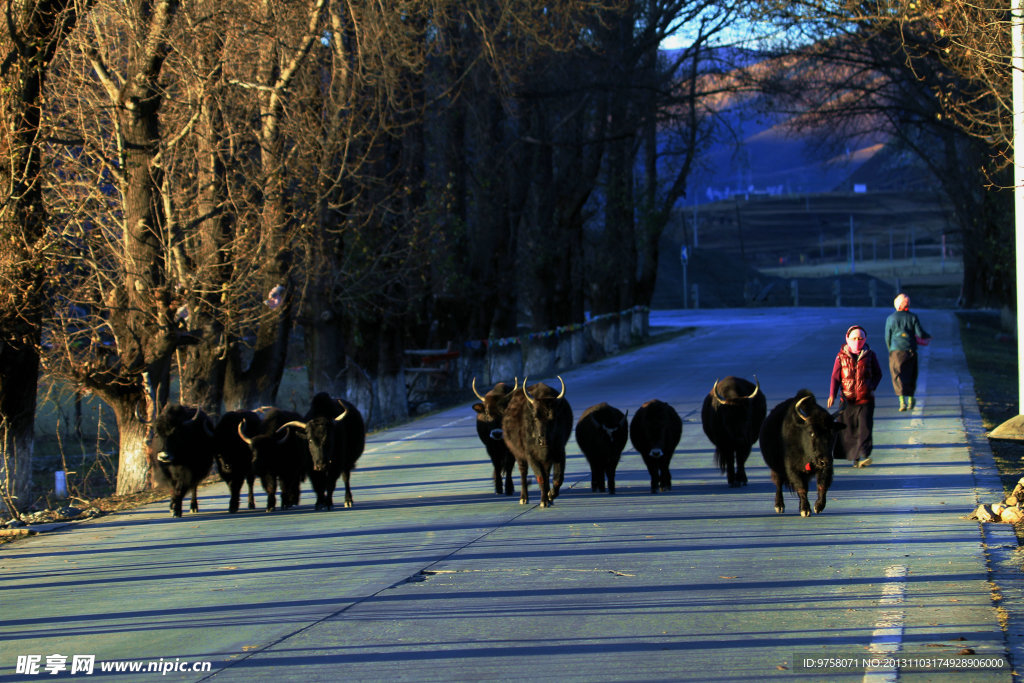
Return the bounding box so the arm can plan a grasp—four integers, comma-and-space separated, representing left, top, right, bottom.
473, 377, 844, 517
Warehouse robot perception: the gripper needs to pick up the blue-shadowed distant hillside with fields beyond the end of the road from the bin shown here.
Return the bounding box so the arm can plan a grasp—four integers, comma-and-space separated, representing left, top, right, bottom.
651, 52, 962, 308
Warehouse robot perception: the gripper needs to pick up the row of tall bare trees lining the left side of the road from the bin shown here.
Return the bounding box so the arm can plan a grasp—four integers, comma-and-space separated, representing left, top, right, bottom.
0, 0, 1001, 511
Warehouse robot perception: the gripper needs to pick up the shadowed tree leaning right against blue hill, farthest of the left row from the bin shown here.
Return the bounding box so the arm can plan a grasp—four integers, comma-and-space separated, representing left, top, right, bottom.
589, 0, 746, 332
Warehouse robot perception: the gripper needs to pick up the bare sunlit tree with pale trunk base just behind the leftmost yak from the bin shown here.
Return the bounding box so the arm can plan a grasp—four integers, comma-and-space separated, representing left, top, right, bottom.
52, 0, 185, 493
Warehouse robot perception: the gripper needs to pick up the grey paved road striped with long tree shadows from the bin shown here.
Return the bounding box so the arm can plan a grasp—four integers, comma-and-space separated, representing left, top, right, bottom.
0, 309, 1024, 681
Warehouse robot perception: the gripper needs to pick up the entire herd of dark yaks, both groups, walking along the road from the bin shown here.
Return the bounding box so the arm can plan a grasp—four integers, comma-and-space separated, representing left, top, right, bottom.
147, 377, 844, 517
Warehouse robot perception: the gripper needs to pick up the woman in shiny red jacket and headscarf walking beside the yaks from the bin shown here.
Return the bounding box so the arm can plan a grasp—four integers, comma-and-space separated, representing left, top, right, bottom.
828, 325, 882, 467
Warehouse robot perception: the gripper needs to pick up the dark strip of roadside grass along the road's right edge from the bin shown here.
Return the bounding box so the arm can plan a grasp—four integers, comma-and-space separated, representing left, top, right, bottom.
956, 311, 1024, 501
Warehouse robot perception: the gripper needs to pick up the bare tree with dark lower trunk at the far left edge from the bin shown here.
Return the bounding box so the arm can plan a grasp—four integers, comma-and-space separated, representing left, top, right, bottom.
0, 0, 77, 514
